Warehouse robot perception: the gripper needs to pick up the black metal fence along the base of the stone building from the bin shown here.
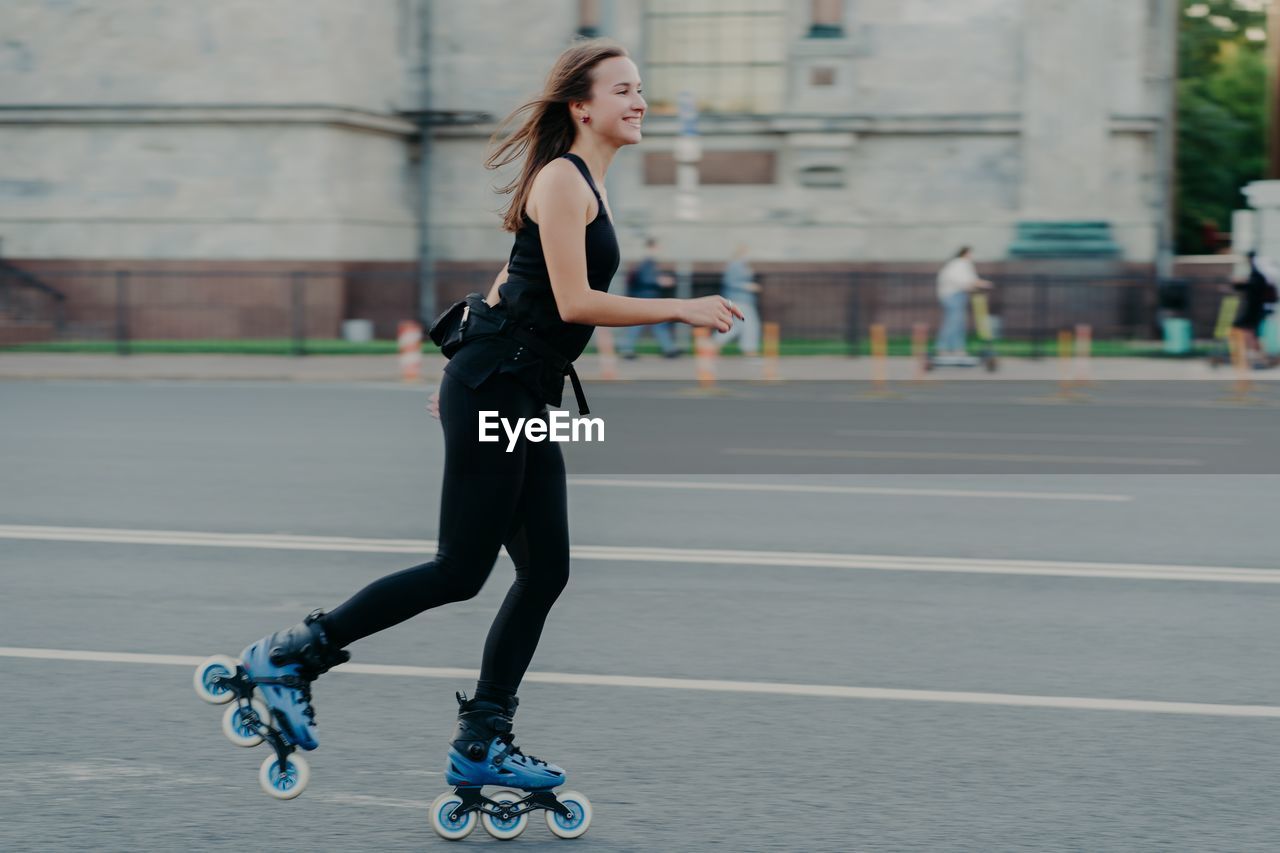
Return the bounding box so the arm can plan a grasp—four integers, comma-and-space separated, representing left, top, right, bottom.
0, 263, 1221, 353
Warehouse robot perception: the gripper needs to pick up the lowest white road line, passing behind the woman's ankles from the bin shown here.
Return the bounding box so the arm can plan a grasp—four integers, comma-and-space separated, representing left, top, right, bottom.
0, 647, 1280, 719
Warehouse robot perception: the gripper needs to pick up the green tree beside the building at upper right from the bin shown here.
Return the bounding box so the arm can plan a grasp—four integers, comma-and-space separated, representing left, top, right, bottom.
1175, 0, 1267, 254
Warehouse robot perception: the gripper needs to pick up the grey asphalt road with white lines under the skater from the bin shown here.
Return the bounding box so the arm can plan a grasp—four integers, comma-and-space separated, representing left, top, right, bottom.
0, 382, 1280, 850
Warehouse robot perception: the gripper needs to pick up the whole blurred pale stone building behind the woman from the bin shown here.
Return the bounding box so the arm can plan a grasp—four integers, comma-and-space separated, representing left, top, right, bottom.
0, 0, 1176, 338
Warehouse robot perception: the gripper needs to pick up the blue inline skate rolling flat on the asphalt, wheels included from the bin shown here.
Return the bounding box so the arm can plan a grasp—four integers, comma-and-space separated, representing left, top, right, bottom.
431, 693, 591, 840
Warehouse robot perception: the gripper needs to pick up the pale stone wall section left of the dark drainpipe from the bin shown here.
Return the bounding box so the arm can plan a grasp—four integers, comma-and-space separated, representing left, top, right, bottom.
0, 0, 419, 260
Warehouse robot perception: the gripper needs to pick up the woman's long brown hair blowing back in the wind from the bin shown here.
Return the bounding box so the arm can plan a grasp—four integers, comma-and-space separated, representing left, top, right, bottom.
485, 38, 630, 231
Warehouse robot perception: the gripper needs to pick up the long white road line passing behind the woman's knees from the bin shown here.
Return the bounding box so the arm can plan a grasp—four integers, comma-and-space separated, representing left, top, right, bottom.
0, 525, 1280, 584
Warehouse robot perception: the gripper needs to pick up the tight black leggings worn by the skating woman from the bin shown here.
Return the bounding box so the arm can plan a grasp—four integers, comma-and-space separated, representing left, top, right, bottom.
324, 373, 568, 695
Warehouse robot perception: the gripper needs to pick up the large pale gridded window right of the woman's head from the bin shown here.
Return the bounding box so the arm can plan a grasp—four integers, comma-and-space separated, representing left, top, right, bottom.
644, 0, 787, 114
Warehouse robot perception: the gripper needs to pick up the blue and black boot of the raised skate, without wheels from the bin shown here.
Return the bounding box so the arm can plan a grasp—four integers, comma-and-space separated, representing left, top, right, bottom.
241, 610, 351, 752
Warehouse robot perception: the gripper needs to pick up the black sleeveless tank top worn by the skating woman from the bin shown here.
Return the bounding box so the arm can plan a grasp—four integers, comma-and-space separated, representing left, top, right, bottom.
444, 154, 621, 406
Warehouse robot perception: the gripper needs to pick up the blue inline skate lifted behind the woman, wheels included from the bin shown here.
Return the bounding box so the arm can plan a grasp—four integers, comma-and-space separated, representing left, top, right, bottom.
195, 610, 351, 799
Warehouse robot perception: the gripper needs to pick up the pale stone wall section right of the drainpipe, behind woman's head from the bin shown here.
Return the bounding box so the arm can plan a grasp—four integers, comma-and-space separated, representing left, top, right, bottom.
431, 0, 1171, 264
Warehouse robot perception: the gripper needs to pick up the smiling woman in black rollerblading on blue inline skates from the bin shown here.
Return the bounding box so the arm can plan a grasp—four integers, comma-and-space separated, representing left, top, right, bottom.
196, 40, 742, 839
